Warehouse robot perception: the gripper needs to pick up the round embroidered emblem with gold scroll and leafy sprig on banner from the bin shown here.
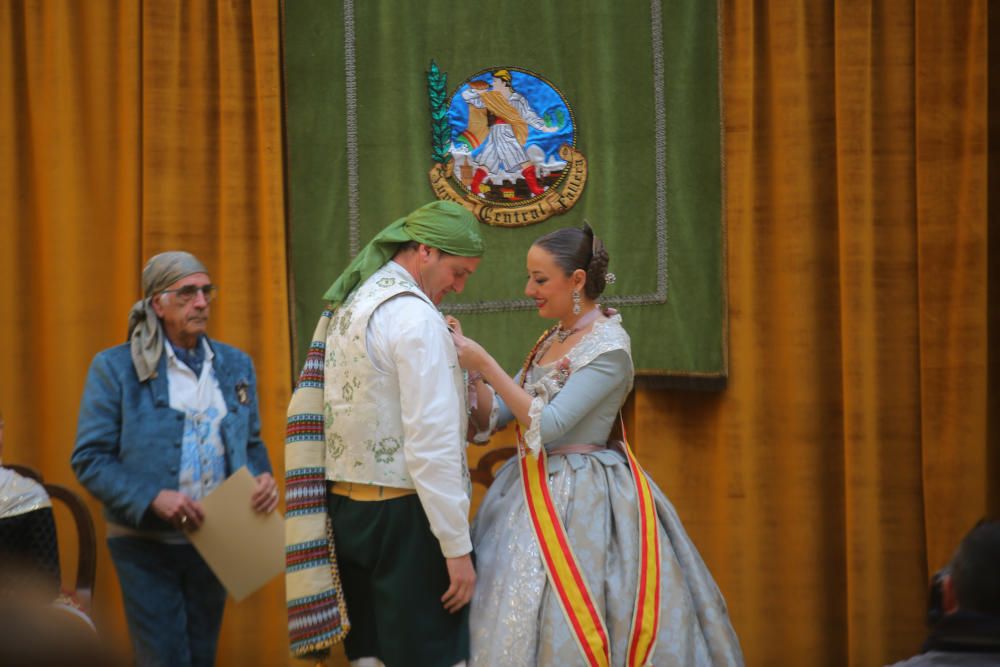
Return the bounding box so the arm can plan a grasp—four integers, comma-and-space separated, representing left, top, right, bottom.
427, 62, 587, 227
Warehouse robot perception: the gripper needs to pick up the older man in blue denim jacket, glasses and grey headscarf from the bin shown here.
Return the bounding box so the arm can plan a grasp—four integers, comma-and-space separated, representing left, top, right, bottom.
71, 252, 278, 667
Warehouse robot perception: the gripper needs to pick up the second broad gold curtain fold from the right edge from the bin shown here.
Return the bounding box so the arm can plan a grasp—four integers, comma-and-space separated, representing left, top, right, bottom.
831, 1, 926, 665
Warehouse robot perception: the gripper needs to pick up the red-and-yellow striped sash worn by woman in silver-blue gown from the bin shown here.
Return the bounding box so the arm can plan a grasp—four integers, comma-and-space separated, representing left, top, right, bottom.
515, 329, 660, 667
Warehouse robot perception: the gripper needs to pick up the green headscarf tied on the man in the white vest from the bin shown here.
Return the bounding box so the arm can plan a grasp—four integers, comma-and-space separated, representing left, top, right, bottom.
323, 201, 486, 308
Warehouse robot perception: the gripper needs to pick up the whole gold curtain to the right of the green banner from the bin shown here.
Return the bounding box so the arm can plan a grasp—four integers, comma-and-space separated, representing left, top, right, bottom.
633, 0, 988, 665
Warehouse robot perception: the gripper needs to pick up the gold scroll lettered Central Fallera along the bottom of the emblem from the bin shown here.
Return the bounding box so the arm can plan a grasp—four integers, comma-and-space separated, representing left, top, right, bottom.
428, 144, 587, 227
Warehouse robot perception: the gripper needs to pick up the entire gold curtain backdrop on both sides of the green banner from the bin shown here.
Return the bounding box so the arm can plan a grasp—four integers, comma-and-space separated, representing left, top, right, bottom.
0, 0, 1000, 666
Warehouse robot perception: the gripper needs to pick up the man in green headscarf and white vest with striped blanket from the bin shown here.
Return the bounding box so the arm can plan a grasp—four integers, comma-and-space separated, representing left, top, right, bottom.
285, 201, 485, 667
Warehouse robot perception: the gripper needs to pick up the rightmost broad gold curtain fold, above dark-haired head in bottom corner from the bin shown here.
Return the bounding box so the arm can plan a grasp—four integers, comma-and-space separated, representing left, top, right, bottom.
914, 0, 1000, 567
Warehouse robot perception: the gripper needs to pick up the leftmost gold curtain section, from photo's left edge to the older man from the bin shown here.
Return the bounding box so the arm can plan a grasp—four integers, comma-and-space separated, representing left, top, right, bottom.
0, 0, 141, 646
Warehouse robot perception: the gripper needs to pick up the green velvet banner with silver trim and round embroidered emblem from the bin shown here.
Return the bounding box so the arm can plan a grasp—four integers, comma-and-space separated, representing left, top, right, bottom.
284, 0, 727, 387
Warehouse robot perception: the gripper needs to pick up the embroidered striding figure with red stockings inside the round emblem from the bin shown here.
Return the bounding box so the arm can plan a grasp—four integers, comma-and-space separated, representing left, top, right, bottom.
462, 69, 559, 197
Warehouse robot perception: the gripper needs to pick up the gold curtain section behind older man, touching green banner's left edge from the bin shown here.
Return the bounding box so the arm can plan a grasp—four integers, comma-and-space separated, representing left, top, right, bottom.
141, 0, 291, 665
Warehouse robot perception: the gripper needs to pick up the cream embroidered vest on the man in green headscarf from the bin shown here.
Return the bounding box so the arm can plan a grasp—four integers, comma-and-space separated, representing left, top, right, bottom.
323, 269, 468, 489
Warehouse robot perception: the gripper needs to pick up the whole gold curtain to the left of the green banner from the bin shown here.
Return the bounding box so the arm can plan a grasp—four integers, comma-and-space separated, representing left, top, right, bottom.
0, 0, 291, 665
